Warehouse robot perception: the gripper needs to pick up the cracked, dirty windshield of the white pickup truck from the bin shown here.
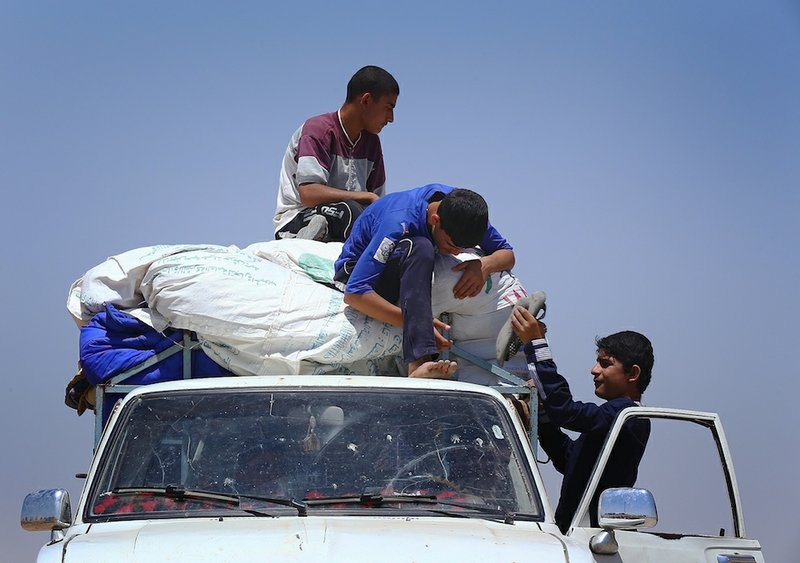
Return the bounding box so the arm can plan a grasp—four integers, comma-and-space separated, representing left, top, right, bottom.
84, 388, 541, 521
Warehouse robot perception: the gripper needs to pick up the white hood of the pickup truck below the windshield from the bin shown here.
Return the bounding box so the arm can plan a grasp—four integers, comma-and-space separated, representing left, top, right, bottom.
61, 516, 565, 563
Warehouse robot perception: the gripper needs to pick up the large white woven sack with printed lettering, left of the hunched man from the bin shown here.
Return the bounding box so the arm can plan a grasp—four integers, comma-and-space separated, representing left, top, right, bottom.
141, 249, 402, 374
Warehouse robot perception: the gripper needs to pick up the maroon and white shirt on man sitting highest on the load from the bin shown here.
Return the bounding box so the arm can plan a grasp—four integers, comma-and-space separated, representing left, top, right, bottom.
273, 111, 386, 232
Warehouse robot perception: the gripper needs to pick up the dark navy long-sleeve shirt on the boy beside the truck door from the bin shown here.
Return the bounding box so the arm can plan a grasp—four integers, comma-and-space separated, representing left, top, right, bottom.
524, 339, 650, 533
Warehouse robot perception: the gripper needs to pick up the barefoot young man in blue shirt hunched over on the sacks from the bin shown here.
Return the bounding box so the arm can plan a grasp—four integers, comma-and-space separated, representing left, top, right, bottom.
335, 184, 514, 377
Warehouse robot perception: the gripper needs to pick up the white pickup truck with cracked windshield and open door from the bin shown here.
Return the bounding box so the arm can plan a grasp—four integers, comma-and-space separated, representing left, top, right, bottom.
21, 376, 764, 563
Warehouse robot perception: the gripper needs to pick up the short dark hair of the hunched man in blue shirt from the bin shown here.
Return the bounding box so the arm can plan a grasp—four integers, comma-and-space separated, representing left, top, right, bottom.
436, 188, 489, 248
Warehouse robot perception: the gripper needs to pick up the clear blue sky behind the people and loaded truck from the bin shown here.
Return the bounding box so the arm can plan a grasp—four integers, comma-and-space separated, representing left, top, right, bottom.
0, 0, 800, 561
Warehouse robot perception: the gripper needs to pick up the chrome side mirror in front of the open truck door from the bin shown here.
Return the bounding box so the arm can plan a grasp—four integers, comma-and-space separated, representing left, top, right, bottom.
589, 488, 658, 555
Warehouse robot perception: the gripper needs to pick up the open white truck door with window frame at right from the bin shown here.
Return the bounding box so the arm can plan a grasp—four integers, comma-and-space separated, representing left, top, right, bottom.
568, 407, 764, 563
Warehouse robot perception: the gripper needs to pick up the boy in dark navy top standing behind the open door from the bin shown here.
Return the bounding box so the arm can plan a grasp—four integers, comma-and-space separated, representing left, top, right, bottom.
511, 307, 654, 533
